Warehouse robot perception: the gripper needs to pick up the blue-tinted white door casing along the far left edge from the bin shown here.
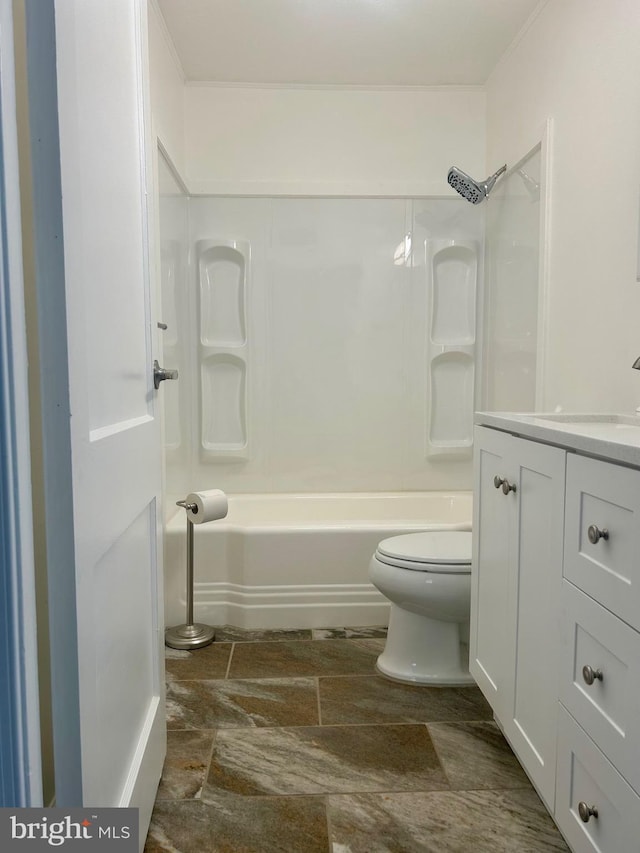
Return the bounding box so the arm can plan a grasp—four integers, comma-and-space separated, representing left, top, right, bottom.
0, 0, 42, 807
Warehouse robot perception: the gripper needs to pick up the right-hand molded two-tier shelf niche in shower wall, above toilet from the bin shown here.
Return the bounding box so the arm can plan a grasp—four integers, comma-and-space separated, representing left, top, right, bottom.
425, 239, 478, 456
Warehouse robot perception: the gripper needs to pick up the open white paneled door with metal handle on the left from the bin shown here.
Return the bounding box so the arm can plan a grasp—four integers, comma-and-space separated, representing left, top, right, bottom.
54, 0, 165, 835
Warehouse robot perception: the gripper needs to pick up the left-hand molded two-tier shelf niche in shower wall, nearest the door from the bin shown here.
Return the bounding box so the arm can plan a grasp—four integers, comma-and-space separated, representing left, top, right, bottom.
196, 239, 251, 462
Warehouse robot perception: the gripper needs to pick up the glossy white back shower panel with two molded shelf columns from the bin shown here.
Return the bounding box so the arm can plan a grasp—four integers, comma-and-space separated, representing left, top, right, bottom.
179, 197, 482, 493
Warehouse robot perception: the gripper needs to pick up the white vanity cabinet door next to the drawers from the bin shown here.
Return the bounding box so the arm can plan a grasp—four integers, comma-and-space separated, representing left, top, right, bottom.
501, 438, 566, 810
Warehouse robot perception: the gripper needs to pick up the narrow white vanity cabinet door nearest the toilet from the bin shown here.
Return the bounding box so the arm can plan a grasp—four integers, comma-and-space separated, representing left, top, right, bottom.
469, 427, 513, 719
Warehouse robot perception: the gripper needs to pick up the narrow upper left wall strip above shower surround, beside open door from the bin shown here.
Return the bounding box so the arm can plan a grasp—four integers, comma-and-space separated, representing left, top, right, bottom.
149, 0, 186, 175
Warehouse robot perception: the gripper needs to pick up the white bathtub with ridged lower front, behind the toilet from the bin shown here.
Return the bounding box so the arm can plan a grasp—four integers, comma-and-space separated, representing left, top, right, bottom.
164, 492, 471, 628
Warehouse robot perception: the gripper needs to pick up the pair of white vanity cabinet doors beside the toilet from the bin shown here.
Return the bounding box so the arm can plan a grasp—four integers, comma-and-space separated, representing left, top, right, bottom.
470, 427, 566, 809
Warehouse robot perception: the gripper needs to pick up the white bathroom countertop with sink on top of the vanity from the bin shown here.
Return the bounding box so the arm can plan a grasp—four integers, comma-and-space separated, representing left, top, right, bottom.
475, 412, 640, 468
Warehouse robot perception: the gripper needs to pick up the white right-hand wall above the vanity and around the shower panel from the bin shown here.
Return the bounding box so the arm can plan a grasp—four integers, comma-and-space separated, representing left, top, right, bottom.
487, 0, 640, 411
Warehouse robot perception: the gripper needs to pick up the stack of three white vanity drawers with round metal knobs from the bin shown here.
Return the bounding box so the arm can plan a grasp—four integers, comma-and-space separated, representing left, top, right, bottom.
555, 454, 640, 853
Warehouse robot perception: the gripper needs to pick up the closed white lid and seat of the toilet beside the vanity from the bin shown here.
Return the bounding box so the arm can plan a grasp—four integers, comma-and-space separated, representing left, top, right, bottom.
376, 530, 471, 572
